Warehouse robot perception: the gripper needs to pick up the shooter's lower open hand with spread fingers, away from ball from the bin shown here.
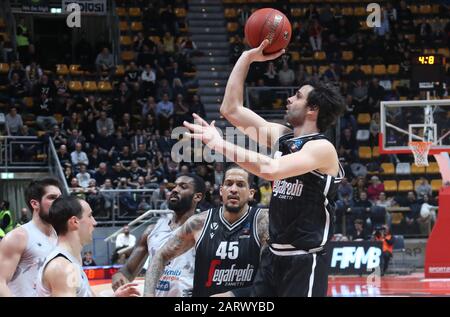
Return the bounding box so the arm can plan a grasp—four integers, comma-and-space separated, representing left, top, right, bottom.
183, 113, 223, 149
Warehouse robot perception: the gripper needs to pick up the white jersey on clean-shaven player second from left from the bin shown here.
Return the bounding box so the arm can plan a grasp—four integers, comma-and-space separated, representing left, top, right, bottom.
37, 247, 94, 297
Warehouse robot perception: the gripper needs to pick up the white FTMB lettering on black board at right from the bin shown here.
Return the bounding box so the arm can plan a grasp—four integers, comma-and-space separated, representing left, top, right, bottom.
331, 247, 381, 270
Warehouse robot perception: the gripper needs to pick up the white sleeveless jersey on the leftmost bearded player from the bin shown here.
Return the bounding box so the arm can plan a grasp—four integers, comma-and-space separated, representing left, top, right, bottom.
8, 221, 58, 297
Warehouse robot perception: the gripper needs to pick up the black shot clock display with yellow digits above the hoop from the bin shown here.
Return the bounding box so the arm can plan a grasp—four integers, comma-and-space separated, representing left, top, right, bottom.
411, 54, 446, 90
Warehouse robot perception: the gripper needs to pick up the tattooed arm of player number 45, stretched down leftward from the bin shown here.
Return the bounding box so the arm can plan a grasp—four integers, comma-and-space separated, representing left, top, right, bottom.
144, 212, 208, 296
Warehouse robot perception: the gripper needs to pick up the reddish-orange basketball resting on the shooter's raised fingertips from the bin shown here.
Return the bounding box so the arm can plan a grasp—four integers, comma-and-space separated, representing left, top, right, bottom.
245, 8, 292, 54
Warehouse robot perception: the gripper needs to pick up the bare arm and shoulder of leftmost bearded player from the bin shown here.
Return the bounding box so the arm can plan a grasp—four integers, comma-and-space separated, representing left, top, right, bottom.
0, 228, 28, 297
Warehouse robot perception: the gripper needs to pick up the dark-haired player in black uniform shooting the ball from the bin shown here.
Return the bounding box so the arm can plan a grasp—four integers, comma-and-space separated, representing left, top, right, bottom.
184, 39, 344, 297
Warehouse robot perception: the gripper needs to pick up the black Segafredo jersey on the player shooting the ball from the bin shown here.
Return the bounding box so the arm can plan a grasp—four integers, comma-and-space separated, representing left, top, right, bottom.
269, 133, 344, 255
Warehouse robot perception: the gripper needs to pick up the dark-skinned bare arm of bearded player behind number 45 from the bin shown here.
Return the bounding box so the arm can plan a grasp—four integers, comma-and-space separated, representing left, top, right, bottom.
112, 224, 155, 291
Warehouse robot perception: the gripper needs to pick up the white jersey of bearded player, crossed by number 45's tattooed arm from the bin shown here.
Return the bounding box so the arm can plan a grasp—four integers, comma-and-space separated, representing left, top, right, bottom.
147, 215, 195, 297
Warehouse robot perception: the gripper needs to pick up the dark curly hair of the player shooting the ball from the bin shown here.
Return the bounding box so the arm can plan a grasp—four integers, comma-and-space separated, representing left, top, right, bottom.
302, 81, 345, 132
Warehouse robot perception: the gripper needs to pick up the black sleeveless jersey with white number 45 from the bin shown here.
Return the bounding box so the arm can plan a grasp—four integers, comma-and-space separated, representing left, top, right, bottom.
192, 207, 261, 297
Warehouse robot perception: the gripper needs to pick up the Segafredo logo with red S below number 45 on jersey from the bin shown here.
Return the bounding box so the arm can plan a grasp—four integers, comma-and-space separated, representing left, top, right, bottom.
205, 260, 255, 287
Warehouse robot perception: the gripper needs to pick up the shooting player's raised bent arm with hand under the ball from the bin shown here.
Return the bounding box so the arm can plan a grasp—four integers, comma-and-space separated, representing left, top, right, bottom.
220, 40, 290, 147
